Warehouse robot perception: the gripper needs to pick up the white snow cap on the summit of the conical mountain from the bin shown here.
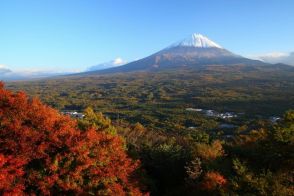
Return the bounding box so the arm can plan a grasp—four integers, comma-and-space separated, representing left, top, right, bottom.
171, 33, 222, 48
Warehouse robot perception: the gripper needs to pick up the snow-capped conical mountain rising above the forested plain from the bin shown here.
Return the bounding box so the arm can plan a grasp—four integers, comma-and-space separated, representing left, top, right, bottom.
84, 33, 266, 73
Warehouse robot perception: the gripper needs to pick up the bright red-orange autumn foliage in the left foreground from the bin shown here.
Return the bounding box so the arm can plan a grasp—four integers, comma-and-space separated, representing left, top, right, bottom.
0, 83, 141, 195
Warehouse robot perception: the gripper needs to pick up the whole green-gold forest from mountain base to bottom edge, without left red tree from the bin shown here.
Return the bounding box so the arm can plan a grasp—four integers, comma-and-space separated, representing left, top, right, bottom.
7, 65, 294, 195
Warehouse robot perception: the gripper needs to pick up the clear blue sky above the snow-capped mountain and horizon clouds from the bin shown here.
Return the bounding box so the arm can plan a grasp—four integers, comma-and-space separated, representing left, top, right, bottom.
0, 0, 294, 71
